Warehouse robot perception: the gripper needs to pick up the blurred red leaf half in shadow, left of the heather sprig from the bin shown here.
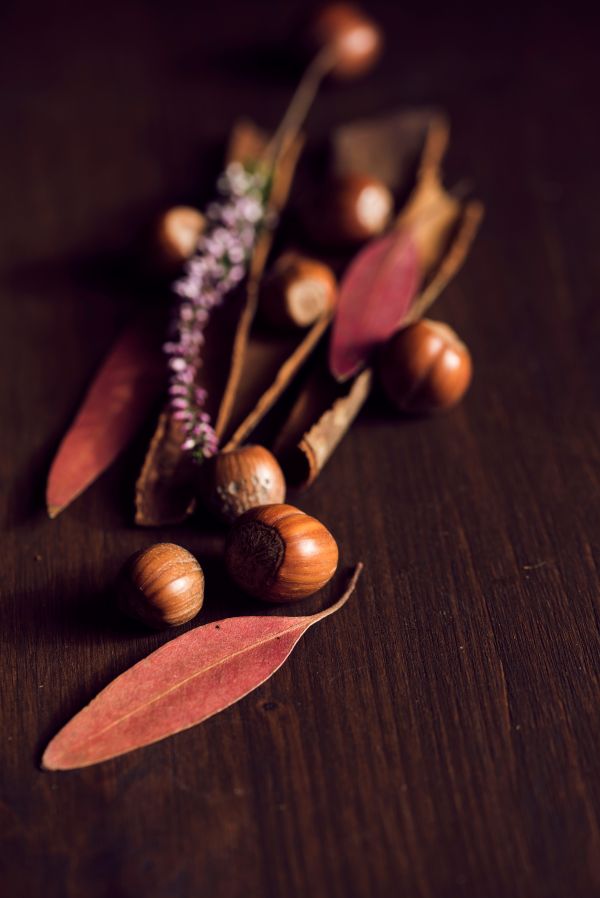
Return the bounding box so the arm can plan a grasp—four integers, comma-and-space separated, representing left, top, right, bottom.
46, 322, 166, 518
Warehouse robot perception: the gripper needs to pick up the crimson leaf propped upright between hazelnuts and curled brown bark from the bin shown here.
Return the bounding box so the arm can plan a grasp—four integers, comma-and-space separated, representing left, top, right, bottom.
329, 229, 422, 381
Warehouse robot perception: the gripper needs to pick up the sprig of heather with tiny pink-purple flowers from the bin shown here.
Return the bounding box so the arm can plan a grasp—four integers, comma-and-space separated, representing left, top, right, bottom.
164, 162, 270, 462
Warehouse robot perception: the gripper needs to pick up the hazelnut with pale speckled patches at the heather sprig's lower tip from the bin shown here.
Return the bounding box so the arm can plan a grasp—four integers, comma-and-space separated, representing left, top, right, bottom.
201, 446, 285, 523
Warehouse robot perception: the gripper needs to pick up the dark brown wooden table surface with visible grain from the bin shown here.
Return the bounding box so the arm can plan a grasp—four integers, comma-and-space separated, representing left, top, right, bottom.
0, 0, 600, 898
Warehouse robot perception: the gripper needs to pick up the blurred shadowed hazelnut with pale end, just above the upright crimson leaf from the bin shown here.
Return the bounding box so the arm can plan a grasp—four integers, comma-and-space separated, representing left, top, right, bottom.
305, 174, 394, 246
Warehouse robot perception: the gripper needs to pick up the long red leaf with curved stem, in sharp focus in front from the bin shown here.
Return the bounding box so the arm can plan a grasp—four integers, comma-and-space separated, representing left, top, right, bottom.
42, 564, 362, 770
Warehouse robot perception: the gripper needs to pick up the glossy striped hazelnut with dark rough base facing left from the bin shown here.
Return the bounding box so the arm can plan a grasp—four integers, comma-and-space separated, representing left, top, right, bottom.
225, 505, 338, 602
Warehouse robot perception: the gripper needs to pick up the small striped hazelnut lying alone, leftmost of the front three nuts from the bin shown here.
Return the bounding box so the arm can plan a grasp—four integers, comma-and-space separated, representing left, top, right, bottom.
119, 543, 204, 630
